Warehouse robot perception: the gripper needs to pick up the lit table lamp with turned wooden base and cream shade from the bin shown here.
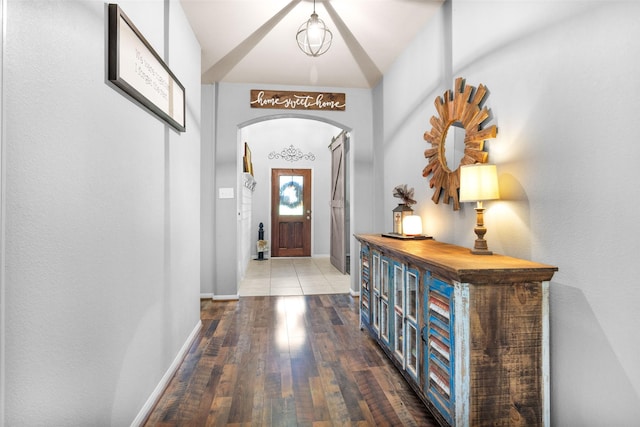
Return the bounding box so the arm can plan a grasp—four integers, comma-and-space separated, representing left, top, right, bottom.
460, 163, 500, 255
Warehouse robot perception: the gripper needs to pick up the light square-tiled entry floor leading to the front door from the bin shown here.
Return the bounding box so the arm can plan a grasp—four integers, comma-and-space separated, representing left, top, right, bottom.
238, 257, 351, 296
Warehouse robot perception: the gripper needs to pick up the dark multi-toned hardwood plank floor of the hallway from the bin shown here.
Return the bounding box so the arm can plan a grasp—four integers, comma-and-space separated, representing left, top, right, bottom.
145, 294, 437, 426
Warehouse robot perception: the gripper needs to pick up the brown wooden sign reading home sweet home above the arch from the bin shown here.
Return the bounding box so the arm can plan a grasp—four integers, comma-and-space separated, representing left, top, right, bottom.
250, 89, 346, 111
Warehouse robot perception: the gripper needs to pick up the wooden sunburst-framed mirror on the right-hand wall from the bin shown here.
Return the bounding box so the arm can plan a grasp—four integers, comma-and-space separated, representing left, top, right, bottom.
422, 77, 498, 211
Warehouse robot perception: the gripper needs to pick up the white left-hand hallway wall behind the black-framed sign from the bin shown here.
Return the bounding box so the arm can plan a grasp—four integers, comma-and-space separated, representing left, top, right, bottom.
0, 0, 200, 426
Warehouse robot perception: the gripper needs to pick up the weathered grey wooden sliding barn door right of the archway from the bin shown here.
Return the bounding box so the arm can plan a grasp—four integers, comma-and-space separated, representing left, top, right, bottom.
329, 132, 347, 274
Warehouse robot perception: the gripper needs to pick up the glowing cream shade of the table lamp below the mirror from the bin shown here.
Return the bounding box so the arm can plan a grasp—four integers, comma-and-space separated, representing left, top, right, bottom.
460, 163, 500, 202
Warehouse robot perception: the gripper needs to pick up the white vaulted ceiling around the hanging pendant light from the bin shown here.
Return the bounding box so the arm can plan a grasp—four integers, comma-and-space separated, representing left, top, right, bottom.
181, 0, 443, 88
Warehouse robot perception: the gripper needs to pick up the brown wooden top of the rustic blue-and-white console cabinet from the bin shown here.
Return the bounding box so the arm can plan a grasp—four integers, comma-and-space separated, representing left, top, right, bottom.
355, 234, 558, 284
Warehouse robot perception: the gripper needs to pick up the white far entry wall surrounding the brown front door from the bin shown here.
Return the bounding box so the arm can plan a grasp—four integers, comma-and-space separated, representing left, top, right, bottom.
240, 118, 342, 256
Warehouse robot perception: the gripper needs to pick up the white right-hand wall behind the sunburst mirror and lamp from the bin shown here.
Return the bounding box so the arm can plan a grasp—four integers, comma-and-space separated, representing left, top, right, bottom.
374, 0, 640, 426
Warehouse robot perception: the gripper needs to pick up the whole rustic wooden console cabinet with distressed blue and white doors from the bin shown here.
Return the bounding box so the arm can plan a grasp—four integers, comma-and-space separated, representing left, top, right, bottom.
355, 234, 557, 426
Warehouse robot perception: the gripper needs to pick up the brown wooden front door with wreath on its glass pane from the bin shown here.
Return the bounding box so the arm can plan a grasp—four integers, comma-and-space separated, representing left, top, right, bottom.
271, 169, 311, 257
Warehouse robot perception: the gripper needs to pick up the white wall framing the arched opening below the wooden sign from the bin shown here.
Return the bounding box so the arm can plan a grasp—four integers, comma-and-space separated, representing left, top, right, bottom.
200, 83, 376, 300
